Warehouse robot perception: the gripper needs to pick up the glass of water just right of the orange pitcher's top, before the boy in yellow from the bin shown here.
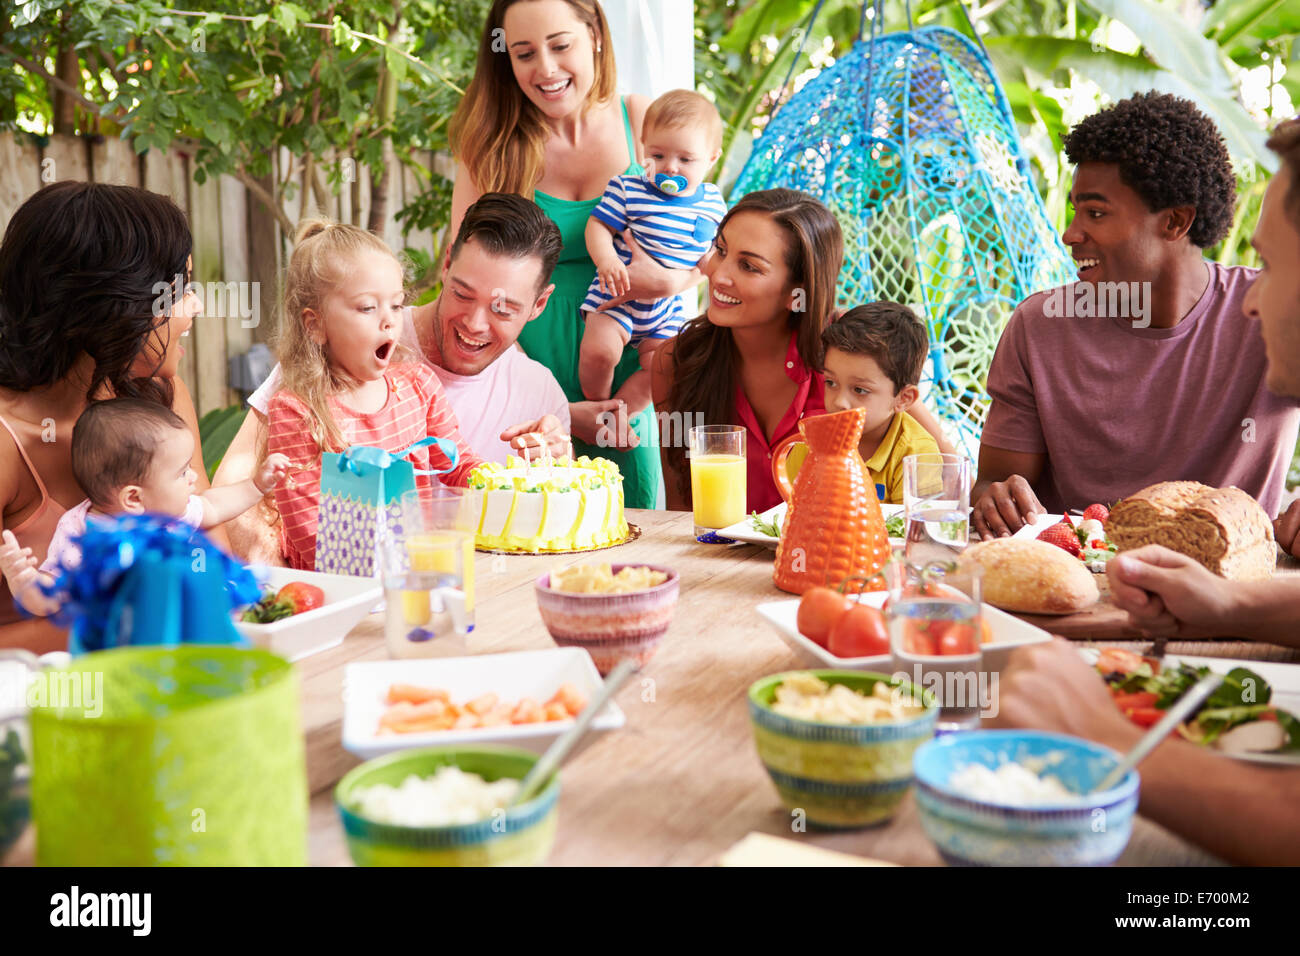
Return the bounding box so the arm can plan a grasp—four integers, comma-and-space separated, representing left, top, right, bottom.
902, 454, 971, 564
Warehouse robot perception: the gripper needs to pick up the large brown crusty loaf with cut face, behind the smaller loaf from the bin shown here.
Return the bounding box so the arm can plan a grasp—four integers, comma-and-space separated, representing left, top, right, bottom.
1106, 481, 1278, 581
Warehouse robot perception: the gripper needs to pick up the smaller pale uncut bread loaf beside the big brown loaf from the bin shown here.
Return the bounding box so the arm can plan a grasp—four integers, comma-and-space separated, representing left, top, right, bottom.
958, 537, 1100, 614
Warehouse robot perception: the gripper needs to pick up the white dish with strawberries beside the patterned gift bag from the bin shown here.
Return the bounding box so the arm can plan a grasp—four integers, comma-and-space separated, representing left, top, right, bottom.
235, 567, 384, 661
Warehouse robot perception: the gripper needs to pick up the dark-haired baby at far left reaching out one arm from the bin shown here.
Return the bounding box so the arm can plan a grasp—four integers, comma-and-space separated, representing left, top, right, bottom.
0, 398, 289, 617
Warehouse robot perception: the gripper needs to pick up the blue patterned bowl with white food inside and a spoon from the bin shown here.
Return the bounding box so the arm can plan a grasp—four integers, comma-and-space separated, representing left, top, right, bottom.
914, 730, 1138, 866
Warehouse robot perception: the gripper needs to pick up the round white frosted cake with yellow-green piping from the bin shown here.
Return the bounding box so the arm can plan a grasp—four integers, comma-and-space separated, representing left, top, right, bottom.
469, 455, 628, 553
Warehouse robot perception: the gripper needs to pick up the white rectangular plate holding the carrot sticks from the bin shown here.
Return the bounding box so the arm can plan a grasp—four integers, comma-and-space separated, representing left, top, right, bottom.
343, 648, 625, 760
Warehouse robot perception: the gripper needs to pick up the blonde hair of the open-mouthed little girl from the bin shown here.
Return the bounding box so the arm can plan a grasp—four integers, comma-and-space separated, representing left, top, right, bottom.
276, 219, 416, 451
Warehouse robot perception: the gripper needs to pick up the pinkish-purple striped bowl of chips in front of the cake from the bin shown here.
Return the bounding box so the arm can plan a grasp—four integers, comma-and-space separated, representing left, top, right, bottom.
536, 562, 677, 675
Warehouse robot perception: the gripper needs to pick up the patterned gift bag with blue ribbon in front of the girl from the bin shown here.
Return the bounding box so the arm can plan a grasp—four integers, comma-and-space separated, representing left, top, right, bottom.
316, 436, 460, 578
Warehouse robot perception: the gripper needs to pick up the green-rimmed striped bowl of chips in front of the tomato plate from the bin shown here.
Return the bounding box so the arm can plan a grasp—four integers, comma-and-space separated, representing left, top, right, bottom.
749, 670, 939, 829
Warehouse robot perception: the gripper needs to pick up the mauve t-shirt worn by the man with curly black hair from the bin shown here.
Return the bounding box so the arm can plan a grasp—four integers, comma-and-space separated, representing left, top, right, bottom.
980, 263, 1300, 515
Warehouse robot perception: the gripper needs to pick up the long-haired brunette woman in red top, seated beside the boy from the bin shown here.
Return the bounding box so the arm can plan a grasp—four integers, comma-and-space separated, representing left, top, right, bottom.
651, 189, 844, 511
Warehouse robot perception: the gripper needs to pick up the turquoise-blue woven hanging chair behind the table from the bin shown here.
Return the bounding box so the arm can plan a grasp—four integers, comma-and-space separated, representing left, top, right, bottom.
731, 3, 1074, 458
